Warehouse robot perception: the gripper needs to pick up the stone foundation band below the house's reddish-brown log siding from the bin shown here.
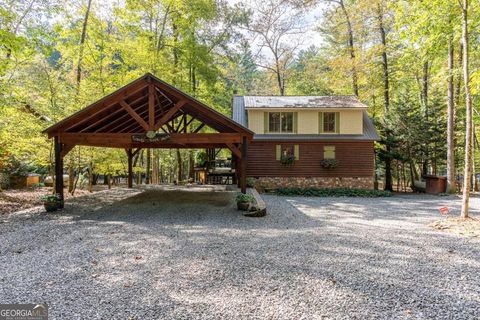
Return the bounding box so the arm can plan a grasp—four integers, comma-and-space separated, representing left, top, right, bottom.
255, 177, 374, 190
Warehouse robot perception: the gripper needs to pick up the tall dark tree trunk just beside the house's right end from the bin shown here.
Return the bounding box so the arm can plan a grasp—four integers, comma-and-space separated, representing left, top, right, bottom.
377, 4, 393, 191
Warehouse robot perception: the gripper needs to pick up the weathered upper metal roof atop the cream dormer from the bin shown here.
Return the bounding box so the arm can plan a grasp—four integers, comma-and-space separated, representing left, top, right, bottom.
243, 96, 367, 109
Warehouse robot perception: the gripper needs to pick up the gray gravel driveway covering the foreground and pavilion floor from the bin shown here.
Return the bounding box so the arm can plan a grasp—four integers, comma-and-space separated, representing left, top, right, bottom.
0, 189, 480, 319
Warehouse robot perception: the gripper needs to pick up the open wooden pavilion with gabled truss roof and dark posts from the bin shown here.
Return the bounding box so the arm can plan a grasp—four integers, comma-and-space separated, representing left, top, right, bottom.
44, 73, 253, 204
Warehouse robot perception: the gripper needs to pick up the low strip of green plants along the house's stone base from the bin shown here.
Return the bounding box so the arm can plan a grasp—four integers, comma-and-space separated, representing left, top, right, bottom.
277, 188, 392, 198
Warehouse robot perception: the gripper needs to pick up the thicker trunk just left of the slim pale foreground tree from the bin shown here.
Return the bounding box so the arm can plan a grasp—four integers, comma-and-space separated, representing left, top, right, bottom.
447, 38, 457, 193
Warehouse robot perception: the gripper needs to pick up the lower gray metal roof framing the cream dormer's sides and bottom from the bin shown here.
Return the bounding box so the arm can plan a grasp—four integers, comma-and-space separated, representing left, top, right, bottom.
232, 96, 380, 141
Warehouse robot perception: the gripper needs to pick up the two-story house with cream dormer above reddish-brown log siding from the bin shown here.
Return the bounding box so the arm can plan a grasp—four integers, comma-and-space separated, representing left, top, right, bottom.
233, 96, 379, 189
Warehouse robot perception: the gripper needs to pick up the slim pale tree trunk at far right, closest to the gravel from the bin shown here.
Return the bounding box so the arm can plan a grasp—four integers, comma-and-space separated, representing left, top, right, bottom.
461, 0, 473, 218
